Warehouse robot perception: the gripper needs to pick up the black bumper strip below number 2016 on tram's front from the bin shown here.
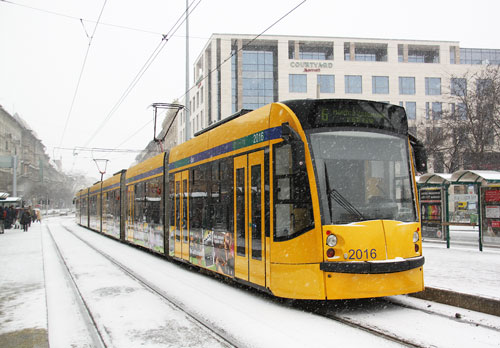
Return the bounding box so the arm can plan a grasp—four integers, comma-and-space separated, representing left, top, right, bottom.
319, 256, 425, 274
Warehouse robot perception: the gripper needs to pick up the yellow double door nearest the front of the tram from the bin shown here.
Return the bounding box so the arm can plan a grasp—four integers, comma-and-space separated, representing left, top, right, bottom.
234, 151, 266, 286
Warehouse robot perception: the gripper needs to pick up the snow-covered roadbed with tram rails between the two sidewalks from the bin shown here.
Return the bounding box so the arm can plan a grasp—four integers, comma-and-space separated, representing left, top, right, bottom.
26, 219, 500, 347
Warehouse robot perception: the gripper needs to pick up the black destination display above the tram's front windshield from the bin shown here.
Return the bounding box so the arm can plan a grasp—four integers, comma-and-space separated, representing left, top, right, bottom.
285, 99, 408, 134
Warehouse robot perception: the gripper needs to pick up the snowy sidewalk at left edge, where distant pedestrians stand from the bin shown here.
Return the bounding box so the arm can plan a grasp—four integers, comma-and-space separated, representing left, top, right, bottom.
0, 223, 49, 348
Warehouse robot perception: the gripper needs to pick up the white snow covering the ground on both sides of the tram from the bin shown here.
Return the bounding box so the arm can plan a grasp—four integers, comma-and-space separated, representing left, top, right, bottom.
0, 218, 500, 347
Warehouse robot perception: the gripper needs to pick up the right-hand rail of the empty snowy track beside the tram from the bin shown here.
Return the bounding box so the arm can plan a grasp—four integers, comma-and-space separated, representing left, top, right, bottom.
57, 226, 238, 348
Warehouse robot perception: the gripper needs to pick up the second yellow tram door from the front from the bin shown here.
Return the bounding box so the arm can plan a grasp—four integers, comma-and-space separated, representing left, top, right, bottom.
175, 170, 189, 260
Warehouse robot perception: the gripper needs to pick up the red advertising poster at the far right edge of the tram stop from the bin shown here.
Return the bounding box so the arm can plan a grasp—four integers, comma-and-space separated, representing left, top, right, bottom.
481, 187, 500, 245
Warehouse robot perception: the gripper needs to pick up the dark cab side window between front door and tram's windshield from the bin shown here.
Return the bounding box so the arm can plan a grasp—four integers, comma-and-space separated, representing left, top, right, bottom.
274, 144, 314, 241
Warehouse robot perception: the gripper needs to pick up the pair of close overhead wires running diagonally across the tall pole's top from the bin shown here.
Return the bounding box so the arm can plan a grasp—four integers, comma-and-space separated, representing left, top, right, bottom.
84, 0, 202, 147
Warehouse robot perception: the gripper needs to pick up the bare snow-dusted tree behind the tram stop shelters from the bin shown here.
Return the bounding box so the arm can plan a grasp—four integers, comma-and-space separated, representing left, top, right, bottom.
425, 65, 500, 172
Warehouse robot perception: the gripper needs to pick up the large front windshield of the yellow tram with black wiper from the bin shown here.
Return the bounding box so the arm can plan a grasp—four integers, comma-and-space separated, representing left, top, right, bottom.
309, 130, 416, 224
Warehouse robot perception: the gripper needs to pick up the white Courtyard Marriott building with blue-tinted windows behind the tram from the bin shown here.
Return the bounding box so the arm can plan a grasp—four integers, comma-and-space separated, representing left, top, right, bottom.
178, 34, 500, 169
